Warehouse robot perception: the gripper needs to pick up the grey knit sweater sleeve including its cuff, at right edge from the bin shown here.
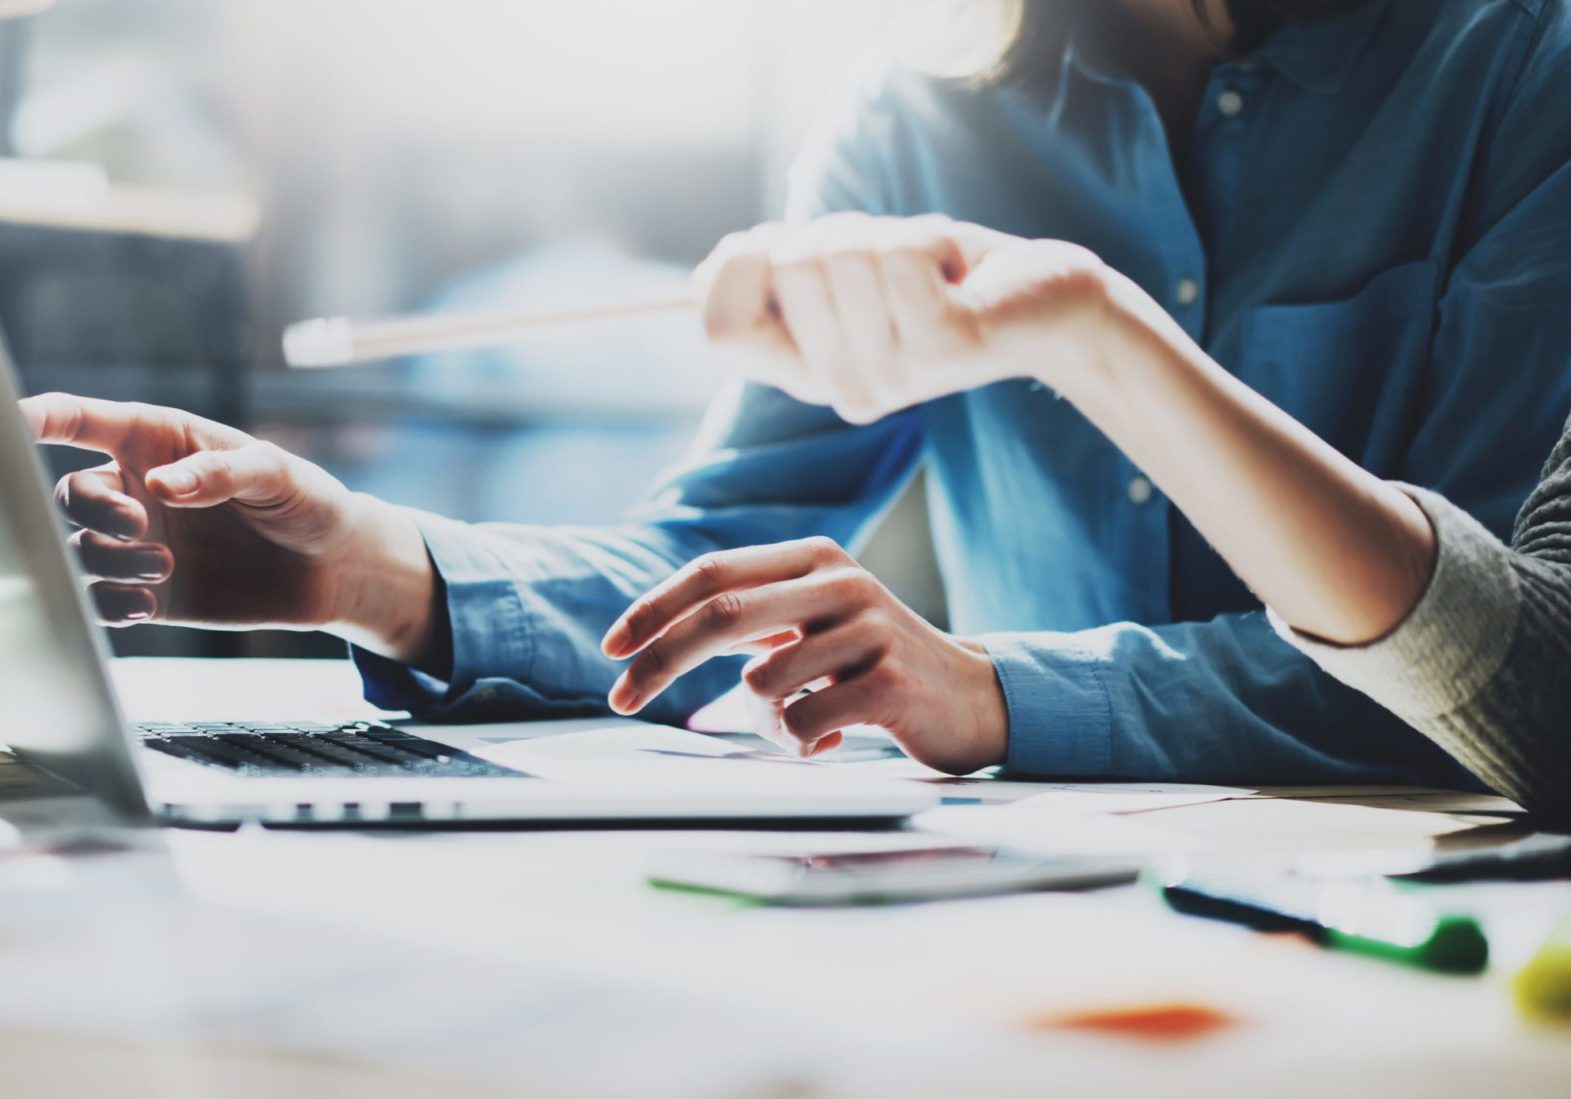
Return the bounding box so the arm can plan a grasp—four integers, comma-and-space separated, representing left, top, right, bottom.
1273, 424, 1571, 821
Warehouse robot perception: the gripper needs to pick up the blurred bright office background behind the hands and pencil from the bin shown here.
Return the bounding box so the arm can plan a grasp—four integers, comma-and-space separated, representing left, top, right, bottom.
0, 0, 939, 655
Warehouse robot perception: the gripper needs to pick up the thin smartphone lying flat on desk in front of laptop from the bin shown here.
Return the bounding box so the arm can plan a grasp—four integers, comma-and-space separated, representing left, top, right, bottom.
649, 846, 1141, 907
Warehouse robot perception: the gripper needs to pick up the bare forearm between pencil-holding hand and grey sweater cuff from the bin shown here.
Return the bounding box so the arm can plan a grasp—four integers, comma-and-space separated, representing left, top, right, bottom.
1045, 275, 1434, 644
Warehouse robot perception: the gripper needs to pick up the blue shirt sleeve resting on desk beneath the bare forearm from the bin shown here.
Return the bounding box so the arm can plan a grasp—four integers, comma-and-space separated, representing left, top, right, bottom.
982, 612, 1477, 788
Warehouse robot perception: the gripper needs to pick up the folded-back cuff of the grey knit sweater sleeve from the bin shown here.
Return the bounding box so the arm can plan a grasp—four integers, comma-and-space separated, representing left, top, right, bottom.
1271, 485, 1521, 722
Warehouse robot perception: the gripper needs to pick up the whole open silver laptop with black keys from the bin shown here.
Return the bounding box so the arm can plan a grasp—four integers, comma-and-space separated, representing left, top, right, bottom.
0, 339, 938, 826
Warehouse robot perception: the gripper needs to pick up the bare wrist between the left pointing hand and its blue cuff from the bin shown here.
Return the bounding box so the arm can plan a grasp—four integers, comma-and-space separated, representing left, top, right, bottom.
327, 493, 445, 666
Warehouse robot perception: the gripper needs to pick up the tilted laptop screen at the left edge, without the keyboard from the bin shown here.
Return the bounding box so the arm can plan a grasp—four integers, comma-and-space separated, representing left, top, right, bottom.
0, 334, 148, 816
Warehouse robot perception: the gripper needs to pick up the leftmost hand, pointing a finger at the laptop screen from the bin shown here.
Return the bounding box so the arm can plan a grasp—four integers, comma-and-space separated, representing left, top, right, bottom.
22, 393, 443, 653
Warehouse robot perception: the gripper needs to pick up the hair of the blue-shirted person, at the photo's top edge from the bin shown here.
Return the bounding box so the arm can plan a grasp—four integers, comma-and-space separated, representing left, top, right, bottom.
980, 0, 1367, 85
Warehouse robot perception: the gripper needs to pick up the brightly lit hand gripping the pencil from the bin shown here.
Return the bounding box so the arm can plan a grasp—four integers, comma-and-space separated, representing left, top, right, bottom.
696, 214, 1117, 424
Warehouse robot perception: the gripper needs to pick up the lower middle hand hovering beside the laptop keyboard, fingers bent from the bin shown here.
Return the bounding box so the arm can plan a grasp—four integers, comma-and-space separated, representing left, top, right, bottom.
603, 539, 1009, 774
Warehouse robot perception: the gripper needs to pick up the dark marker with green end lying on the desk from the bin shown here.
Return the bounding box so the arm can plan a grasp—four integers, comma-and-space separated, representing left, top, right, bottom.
1150, 873, 1489, 973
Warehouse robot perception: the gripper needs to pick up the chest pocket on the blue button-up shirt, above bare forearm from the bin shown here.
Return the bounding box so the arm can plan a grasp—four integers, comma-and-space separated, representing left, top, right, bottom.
1240, 259, 1441, 476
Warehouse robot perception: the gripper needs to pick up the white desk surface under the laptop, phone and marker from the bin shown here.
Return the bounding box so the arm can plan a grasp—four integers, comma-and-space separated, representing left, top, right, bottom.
0, 661, 1571, 1099
